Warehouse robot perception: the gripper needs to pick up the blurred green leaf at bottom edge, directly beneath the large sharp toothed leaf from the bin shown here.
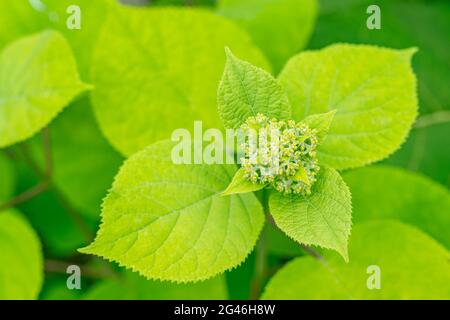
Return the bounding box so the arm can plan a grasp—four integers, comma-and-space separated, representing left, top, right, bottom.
83, 272, 228, 300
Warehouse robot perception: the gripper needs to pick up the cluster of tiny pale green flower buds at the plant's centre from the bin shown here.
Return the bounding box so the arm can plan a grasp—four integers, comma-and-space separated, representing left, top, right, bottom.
240, 114, 320, 195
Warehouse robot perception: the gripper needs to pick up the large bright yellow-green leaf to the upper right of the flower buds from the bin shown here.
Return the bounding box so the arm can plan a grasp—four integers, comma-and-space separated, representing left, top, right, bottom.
280, 44, 417, 169
